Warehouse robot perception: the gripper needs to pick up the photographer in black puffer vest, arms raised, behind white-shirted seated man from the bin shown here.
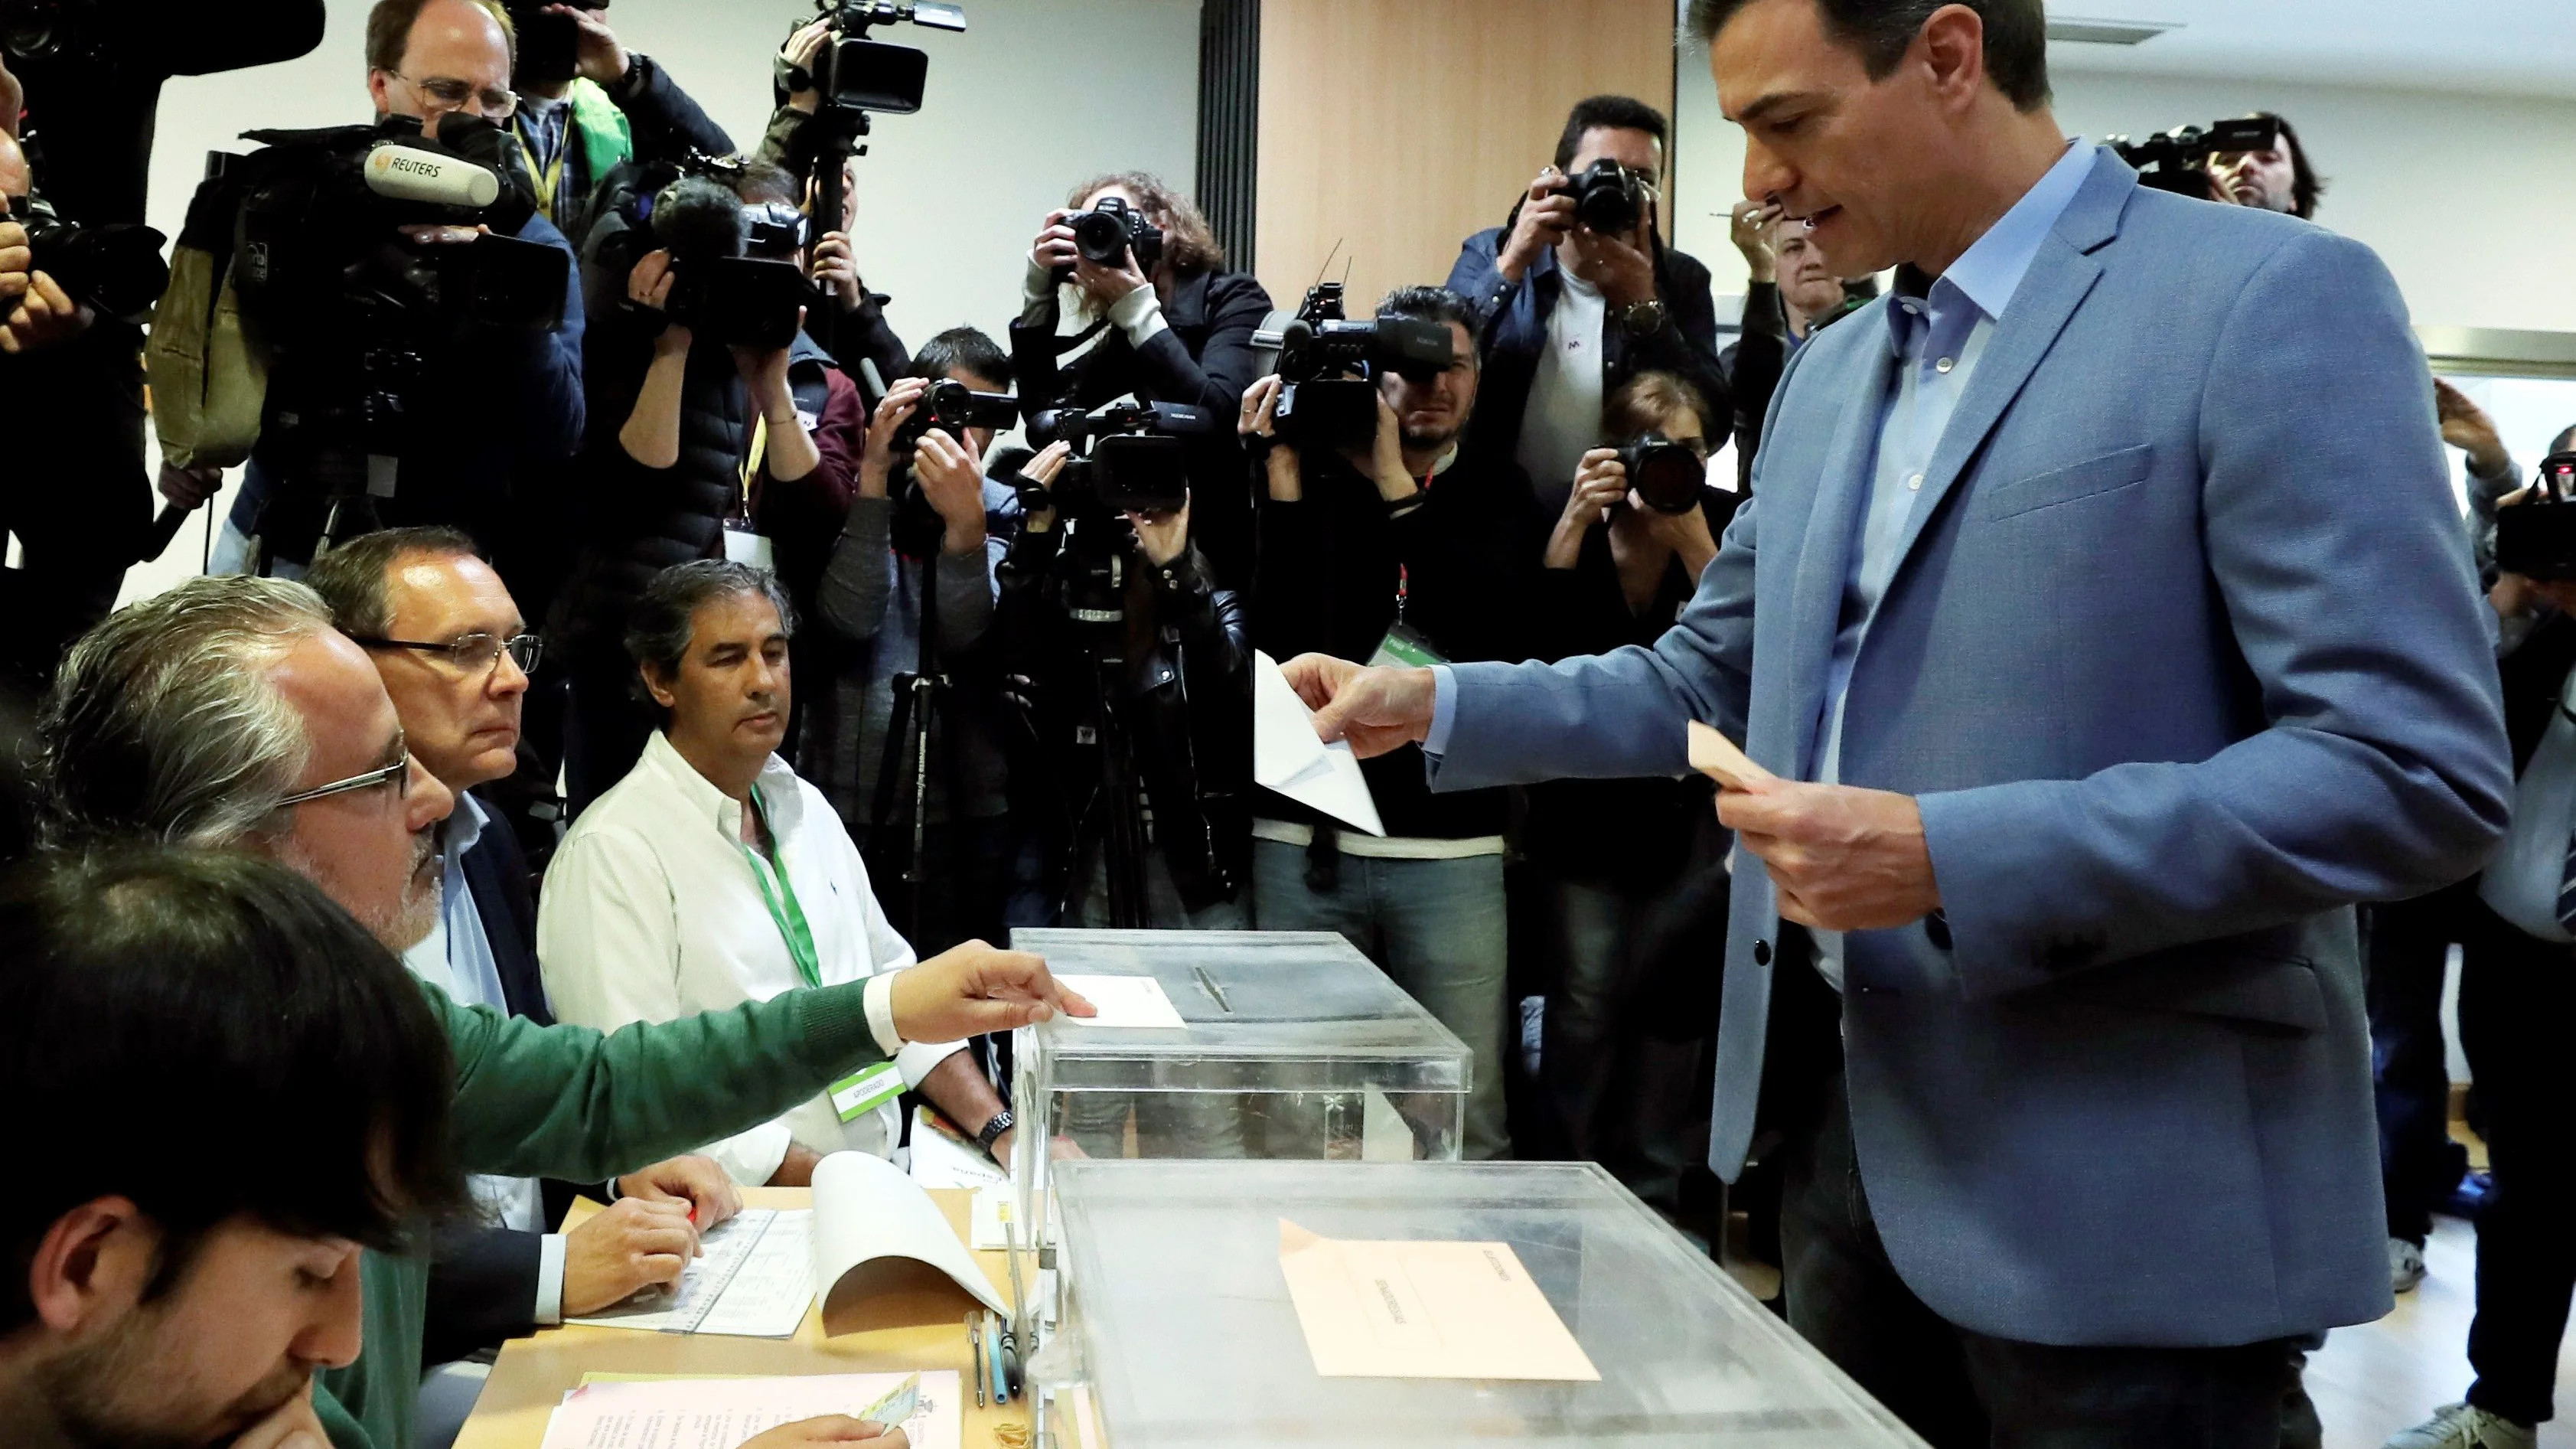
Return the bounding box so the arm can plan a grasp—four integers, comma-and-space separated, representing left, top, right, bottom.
549, 160, 827, 814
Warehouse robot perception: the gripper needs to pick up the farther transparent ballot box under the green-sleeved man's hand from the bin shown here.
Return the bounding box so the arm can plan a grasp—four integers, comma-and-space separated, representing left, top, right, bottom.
1009, 931, 1469, 1194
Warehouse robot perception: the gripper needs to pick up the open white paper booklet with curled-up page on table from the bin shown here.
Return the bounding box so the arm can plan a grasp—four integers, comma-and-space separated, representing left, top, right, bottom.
572, 1153, 1009, 1338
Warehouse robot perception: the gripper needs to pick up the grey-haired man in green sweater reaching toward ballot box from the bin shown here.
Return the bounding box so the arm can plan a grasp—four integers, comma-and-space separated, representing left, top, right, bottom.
36, 575, 1092, 1449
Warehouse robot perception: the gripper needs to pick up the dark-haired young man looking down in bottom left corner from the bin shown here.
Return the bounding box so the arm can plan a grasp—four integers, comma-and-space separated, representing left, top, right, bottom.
0, 848, 904, 1449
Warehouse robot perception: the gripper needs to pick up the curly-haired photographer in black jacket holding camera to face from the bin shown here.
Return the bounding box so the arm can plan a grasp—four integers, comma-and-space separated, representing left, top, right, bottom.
1009, 170, 1270, 588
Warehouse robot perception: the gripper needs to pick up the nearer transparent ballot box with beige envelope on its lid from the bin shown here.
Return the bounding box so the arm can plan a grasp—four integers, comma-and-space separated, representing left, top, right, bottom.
1038, 1160, 1922, 1449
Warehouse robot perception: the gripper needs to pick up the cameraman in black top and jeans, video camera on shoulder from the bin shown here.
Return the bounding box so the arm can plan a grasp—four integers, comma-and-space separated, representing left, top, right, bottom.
1237, 284, 1524, 1157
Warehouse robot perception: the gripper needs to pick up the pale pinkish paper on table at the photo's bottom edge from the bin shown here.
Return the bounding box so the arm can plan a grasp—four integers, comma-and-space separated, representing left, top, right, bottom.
541, 1369, 966, 1449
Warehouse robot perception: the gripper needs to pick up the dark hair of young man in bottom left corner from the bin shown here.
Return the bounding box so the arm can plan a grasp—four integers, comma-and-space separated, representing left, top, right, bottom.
0, 848, 469, 1336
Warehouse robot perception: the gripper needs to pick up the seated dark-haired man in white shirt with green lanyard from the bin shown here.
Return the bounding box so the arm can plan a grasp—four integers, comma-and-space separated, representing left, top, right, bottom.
536, 560, 1012, 1186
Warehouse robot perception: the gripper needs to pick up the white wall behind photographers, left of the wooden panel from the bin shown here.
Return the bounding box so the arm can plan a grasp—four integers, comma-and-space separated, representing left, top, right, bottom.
126, 0, 1198, 598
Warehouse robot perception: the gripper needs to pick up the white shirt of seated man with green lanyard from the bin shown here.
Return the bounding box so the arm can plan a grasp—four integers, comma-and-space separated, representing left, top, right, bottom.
536, 733, 964, 1186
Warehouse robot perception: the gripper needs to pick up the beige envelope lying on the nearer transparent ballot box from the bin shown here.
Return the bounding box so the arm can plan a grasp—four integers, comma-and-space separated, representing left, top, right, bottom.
1280, 1217, 1603, 1382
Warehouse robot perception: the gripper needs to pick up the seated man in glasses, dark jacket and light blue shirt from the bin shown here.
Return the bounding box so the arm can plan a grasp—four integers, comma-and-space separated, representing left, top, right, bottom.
304, 529, 742, 1364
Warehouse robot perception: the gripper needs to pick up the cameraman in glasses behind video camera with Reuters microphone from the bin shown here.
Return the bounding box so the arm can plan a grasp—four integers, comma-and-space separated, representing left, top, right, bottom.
180, 0, 582, 578
